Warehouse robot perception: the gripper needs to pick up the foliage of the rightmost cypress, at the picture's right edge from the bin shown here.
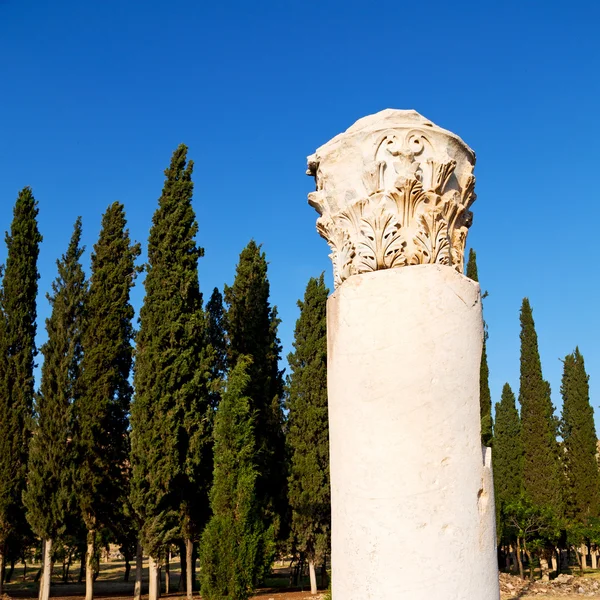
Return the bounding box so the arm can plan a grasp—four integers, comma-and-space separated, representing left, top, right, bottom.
560, 348, 600, 523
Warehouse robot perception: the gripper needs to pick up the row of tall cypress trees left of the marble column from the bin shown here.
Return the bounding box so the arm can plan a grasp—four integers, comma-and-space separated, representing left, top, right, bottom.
0, 145, 329, 600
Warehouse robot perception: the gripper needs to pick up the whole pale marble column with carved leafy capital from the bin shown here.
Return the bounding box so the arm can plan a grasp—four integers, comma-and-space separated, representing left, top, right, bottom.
308, 110, 499, 600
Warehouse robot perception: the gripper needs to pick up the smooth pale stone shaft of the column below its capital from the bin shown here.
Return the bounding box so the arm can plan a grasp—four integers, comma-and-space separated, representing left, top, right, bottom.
327, 265, 499, 600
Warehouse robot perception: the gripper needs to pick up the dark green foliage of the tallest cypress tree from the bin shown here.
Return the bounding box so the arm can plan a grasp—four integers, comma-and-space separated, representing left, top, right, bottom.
131, 145, 212, 557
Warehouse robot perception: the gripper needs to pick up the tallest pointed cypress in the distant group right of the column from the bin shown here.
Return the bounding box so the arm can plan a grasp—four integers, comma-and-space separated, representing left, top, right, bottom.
519, 298, 563, 516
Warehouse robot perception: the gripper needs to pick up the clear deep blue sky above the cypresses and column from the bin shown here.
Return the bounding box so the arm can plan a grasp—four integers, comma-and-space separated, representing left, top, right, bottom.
0, 0, 600, 422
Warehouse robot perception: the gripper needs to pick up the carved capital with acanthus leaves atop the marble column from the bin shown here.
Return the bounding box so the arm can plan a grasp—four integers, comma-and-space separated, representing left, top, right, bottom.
307, 109, 476, 287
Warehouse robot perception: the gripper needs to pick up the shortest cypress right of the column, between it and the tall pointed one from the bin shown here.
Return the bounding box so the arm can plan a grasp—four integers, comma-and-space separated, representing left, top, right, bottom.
493, 383, 523, 538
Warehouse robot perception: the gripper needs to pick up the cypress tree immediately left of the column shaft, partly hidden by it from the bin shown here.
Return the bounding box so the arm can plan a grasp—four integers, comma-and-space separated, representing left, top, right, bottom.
287, 274, 331, 594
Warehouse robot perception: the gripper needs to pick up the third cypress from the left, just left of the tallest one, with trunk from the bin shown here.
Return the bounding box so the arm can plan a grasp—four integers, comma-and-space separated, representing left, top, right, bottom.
74, 202, 140, 600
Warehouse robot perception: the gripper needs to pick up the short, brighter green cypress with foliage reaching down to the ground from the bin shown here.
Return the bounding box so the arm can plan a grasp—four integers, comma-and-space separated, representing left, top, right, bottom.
200, 356, 265, 600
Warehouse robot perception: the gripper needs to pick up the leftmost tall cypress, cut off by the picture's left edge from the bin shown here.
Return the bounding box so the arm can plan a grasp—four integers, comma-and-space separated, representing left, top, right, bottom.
0, 187, 42, 594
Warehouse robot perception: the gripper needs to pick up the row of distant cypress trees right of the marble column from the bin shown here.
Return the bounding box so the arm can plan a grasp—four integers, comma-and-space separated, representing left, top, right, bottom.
467, 250, 600, 577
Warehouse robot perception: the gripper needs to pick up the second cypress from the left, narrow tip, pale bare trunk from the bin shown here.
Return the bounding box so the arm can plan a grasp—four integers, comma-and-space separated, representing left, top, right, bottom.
23, 218, 87, 600
